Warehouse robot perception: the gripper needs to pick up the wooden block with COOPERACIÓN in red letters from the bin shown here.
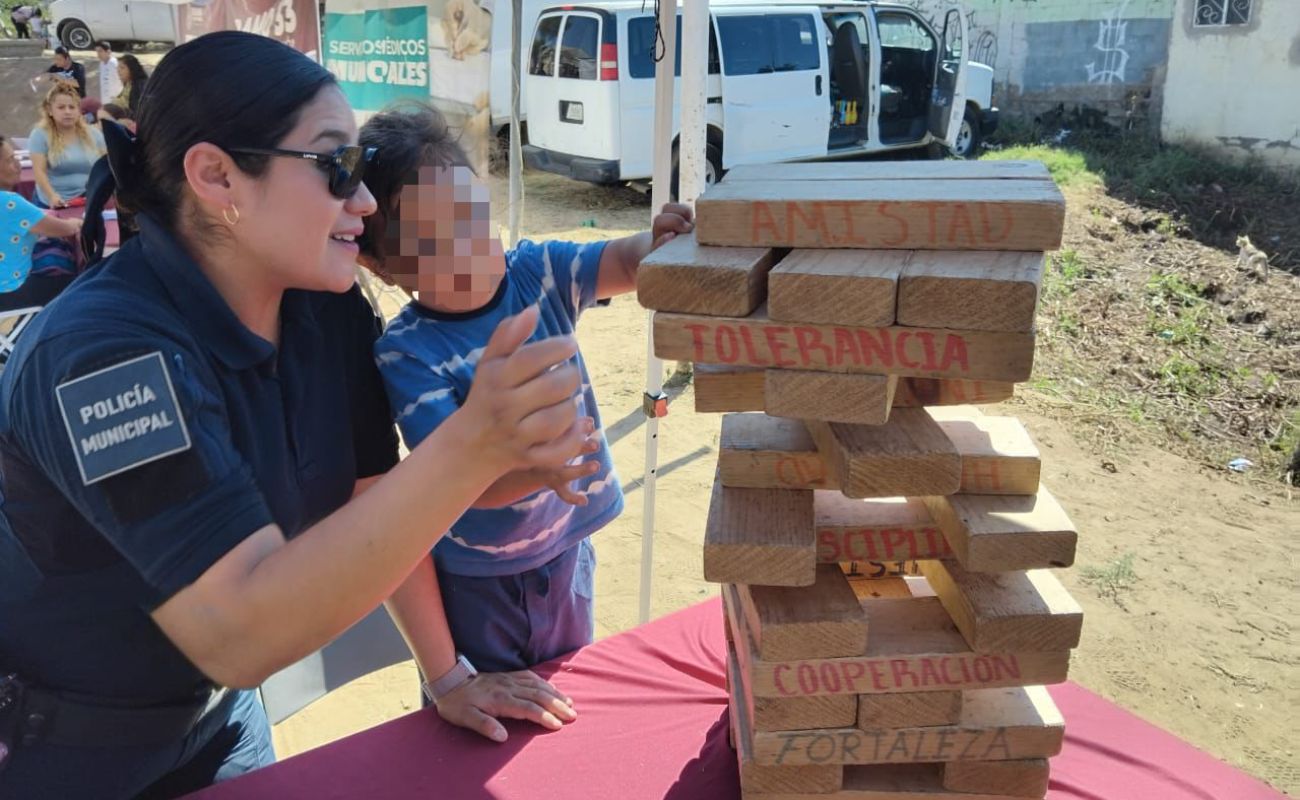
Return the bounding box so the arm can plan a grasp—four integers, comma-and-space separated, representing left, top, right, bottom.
723, 579, 1070, 699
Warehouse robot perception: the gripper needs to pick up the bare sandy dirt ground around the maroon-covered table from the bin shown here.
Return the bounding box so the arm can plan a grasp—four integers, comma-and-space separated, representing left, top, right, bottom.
274, 173, 1300, 793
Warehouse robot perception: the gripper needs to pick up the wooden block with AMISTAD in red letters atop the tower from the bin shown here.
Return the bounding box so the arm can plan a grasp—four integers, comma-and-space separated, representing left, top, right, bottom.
696, 180, 1065, 251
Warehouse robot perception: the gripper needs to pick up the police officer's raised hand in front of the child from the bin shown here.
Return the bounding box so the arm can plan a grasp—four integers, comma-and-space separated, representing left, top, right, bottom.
452, 306, 590, 473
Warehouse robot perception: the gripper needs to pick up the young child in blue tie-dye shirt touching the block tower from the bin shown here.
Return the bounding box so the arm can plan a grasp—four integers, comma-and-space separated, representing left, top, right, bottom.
361, 105, 692, 741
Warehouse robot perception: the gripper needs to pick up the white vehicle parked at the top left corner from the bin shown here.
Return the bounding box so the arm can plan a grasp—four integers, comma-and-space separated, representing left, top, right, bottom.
49, 0, 176, 49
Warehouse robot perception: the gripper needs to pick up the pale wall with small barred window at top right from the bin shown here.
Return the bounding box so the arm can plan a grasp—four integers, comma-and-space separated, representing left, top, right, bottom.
1161, 0, 1300, 168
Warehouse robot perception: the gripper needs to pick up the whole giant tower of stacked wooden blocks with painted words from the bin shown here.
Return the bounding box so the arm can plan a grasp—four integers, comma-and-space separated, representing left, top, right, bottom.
637, 161, 1083, 800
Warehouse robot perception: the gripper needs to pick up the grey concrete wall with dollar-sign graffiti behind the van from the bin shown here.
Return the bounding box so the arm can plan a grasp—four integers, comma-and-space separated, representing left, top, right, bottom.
905, 0, 1175, 126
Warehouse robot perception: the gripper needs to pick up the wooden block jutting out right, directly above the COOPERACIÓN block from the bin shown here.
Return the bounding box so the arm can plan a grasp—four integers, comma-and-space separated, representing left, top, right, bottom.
920, 561, 1083, 653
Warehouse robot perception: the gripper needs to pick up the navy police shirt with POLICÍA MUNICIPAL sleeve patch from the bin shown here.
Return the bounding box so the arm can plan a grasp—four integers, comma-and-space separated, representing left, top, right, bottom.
0, 216, 398, 705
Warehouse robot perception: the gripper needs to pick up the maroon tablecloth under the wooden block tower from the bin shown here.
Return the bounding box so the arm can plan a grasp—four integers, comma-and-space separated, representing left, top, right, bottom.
192, 600, 1283, 800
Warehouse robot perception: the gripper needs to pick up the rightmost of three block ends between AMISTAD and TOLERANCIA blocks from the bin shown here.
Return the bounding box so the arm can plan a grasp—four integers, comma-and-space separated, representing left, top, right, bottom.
894, 250, 1043, 330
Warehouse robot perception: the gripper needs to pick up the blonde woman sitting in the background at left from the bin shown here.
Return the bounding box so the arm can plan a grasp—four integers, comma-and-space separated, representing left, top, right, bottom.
27, 82, 104, 208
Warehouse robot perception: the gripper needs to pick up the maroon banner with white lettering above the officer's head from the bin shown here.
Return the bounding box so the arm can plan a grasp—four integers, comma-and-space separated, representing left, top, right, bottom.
177, 0, 321, 61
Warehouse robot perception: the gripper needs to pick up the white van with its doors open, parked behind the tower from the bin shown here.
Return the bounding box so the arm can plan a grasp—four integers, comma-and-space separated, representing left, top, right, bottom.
524, 0, 997, 183
